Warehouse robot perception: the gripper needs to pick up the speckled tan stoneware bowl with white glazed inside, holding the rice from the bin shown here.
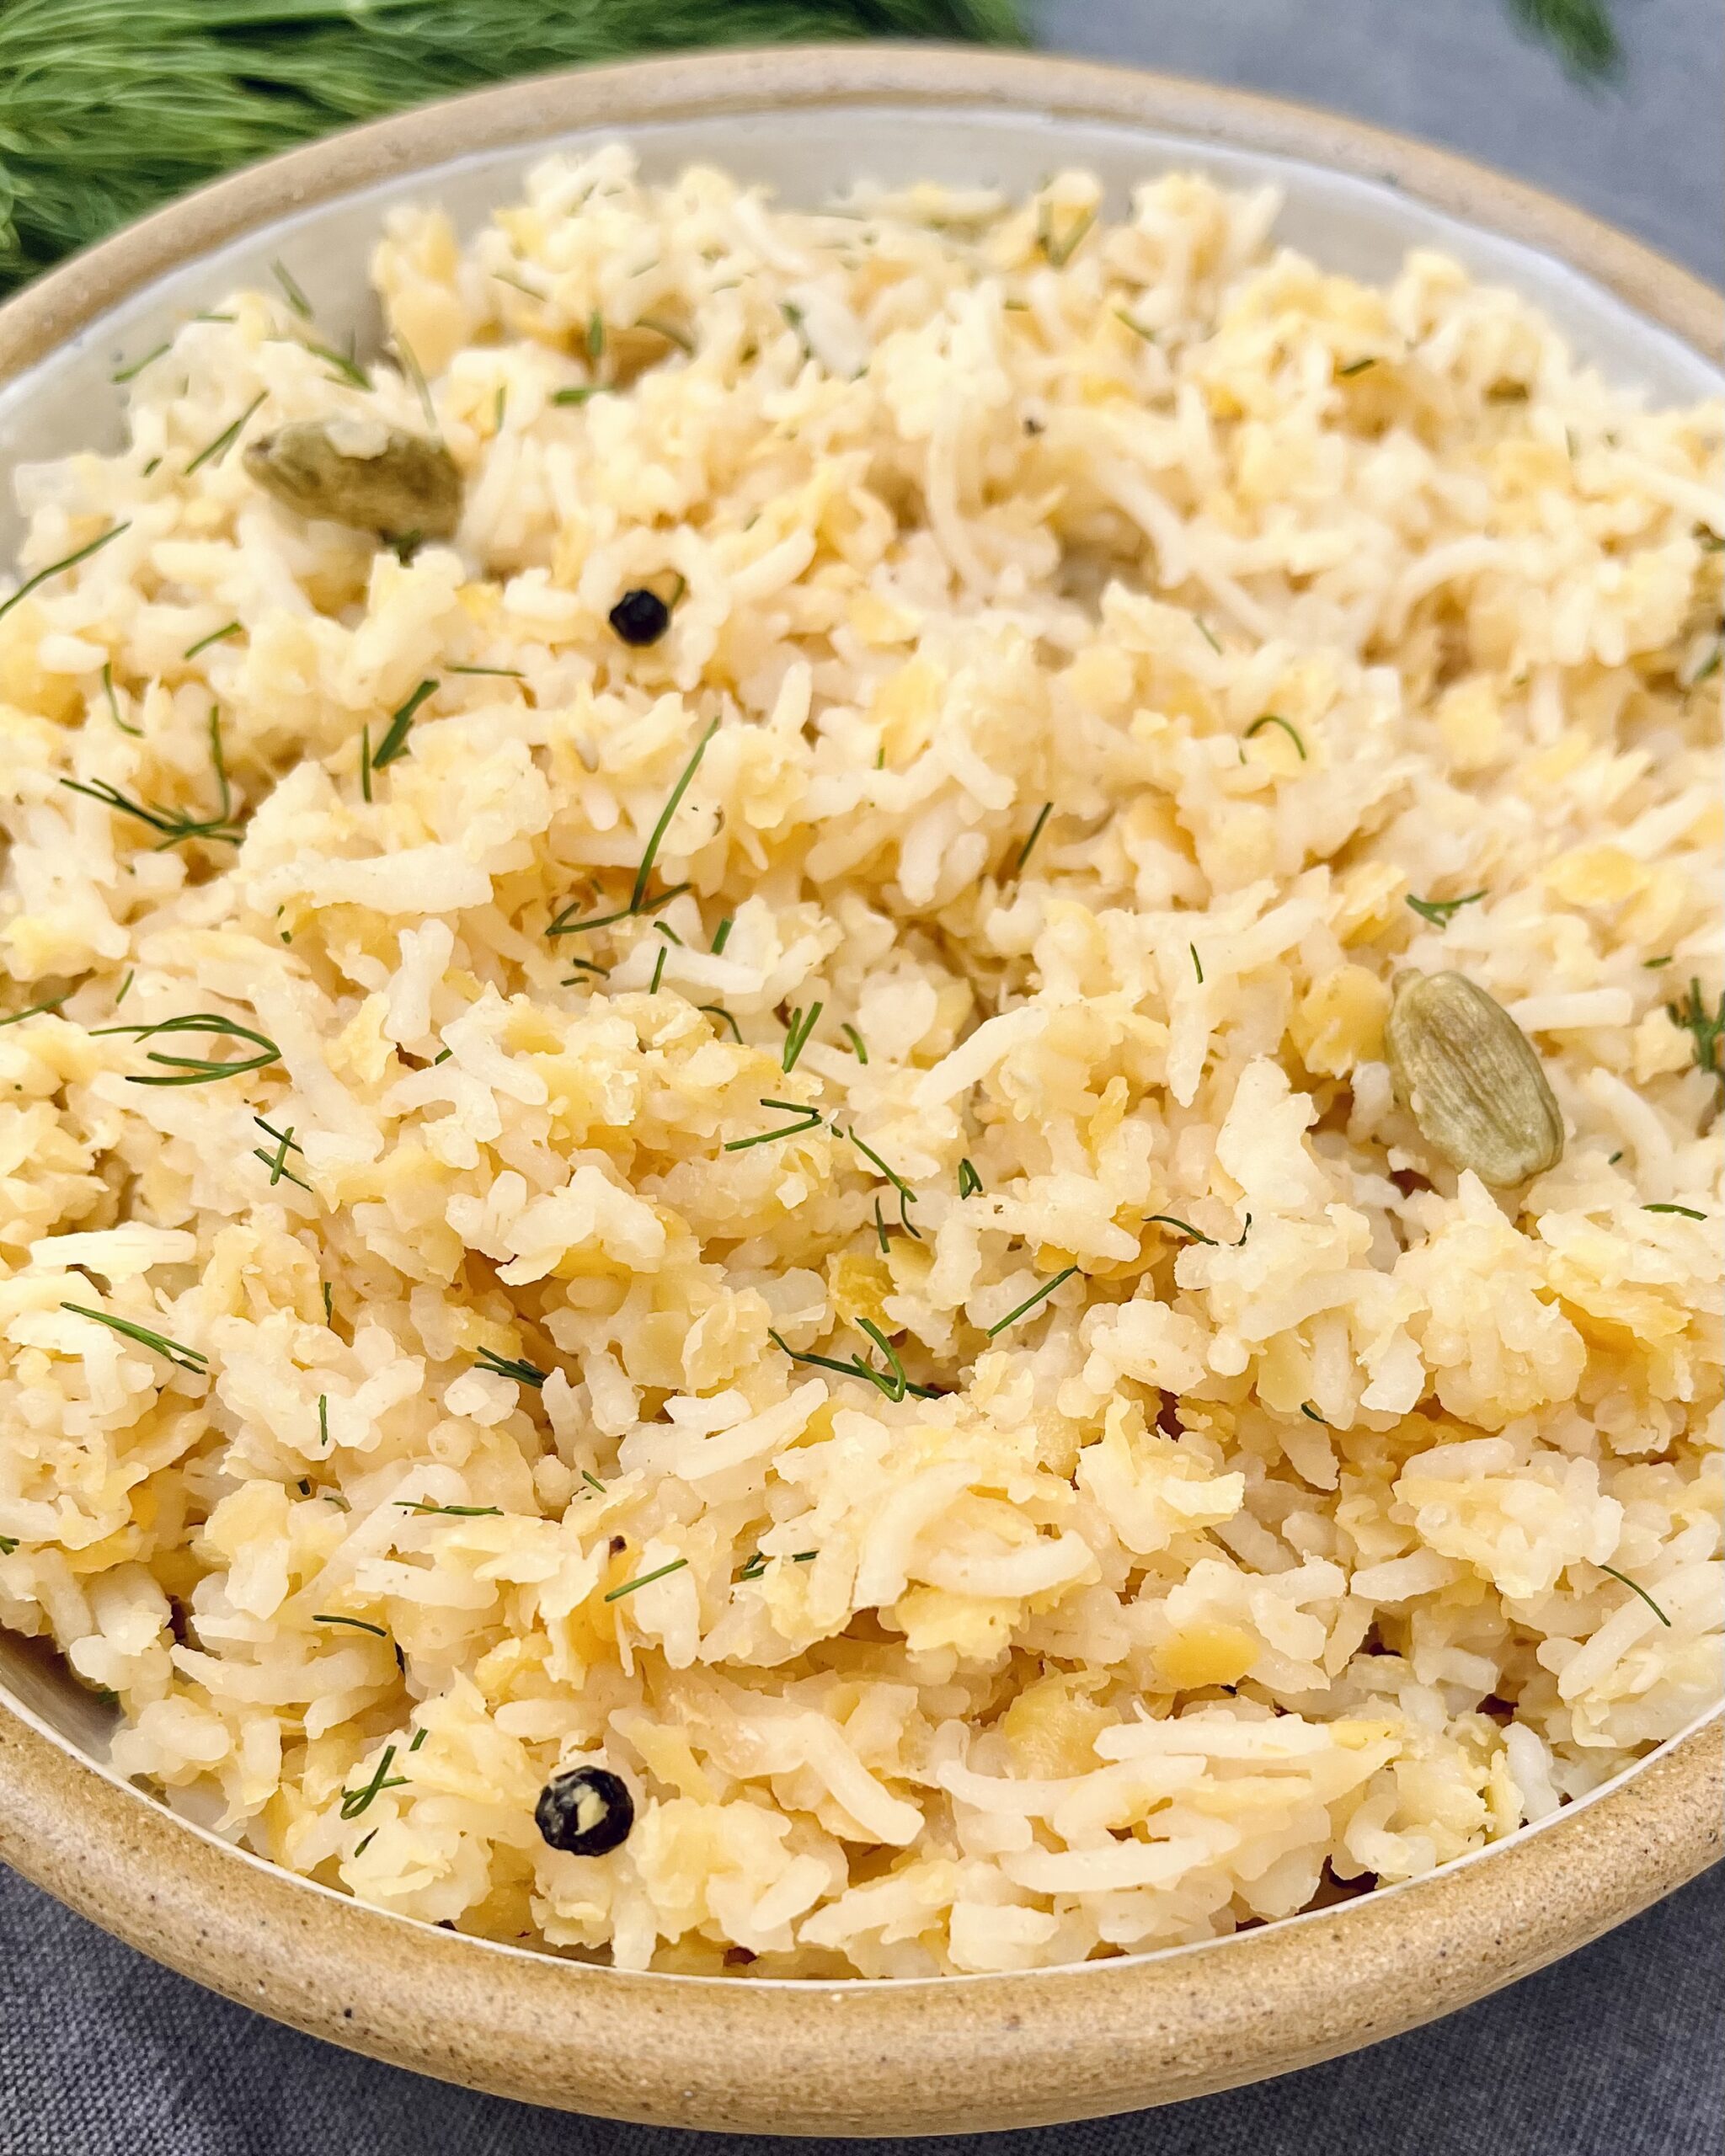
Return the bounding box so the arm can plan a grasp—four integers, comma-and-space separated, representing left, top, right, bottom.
0, 45, 1721, 2134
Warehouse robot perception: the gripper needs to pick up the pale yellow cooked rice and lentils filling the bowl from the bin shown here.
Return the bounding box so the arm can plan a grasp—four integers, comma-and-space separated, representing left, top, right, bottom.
0, 149, 1721, 1977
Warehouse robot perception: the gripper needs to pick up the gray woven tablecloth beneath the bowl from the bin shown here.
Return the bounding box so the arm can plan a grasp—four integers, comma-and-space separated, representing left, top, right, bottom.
0, 0, 1725, 2156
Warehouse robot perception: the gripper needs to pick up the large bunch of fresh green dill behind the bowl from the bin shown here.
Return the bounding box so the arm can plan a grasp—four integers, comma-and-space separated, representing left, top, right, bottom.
0, 0, 1022, 291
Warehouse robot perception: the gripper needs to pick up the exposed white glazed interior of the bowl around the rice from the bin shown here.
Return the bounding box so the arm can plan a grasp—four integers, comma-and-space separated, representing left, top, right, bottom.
0, 99, 1725, 1785
